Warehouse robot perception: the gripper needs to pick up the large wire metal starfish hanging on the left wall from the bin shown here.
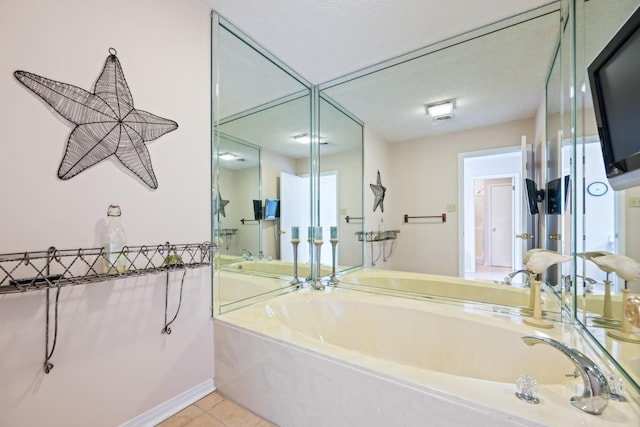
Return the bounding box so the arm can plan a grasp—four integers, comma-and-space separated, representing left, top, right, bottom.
14, 48, 178, 188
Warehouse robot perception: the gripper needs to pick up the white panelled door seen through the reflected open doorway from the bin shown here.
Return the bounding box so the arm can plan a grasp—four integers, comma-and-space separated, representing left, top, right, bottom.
489, 184, 513, 267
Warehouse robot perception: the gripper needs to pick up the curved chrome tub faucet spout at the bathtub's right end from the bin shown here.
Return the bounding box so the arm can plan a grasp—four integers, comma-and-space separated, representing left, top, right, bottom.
522, 336, 611, 415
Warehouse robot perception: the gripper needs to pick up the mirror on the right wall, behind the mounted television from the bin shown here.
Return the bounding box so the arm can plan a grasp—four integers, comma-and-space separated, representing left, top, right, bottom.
564, 0, 640, 390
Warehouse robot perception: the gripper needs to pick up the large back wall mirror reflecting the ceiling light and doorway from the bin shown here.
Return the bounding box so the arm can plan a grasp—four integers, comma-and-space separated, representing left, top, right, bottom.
320, 4, 561, 319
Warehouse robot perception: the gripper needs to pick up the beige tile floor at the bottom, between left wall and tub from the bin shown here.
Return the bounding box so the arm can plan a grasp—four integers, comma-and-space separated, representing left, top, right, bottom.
157, 391, 277, 427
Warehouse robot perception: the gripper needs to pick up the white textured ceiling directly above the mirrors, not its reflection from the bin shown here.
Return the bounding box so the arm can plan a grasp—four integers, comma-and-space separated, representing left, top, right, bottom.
204, 0, 556, 84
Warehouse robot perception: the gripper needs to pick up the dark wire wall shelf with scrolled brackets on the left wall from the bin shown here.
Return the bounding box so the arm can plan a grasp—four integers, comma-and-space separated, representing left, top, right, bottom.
0, 242, 217, 374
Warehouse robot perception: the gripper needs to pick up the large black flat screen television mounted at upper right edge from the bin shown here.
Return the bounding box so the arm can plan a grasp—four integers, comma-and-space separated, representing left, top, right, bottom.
587, 8, 640, 190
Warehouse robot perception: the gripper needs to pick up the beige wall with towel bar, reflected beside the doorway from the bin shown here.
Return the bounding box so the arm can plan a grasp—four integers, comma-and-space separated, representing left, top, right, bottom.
388, 119, 535, 276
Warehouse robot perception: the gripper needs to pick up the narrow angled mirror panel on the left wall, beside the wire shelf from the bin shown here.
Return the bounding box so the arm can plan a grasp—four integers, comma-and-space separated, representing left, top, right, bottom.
212, 16, 310, 313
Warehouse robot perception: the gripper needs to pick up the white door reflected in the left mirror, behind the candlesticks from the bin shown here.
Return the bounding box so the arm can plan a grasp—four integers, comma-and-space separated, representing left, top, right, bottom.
280, 172, 310, 264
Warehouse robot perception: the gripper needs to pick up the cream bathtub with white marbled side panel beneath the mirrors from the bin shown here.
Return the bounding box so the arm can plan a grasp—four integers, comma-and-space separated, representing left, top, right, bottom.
214, 289, 640, 427
